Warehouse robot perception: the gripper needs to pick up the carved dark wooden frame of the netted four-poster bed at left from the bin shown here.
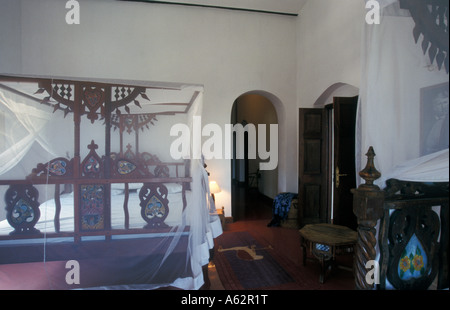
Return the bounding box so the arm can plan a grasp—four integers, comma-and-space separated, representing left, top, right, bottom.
0, 77, 209, 288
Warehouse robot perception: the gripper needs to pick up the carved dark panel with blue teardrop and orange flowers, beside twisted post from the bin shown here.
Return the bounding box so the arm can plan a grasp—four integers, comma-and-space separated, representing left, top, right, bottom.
380, 201, 445, 289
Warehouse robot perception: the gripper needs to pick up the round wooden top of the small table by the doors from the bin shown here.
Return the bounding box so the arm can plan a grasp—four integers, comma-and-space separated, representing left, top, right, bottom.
299, 224, 358, 246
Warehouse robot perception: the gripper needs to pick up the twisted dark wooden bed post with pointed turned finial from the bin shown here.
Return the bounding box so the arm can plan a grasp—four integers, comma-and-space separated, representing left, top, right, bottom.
352, 147, 384, 290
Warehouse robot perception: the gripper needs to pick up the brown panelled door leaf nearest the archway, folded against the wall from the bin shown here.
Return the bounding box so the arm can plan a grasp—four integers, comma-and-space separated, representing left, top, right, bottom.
298, 109, 329, 226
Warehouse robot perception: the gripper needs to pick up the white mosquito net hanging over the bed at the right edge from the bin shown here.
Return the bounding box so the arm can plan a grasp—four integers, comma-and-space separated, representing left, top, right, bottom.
356, 0, 449, 187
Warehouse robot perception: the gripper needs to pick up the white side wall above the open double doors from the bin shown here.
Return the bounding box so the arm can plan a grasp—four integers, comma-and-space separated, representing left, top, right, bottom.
297, 0, 366, 108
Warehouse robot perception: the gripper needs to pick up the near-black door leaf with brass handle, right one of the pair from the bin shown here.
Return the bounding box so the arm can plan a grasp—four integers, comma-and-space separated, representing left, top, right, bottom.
333, 96, 358, 229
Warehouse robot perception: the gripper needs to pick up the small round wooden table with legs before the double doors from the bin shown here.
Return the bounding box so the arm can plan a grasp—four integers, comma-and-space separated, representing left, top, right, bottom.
299, 224, 358, 283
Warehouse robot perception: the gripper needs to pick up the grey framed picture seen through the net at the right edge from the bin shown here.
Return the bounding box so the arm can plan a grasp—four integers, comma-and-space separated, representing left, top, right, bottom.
420, 82, 449, 155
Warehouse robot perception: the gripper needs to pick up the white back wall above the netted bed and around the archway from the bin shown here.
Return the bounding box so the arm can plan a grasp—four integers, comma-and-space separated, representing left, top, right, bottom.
0, 0, 298, 216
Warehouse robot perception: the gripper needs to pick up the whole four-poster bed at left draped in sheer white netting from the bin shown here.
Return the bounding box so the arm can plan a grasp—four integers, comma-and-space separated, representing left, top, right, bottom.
0, 75, 221, 289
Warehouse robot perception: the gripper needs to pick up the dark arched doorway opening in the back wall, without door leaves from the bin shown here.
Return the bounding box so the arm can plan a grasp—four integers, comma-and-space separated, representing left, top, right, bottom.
231, 92, 278, 220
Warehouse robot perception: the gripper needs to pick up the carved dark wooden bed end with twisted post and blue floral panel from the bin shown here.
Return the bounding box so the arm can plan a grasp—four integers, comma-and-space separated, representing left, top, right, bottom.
352, 147, 449, 290
